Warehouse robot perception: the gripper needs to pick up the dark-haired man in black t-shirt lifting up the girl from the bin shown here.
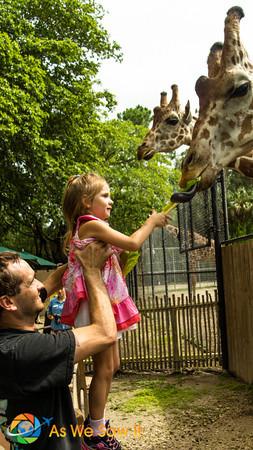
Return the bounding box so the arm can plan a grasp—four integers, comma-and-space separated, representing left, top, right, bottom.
0, 242, 117, 450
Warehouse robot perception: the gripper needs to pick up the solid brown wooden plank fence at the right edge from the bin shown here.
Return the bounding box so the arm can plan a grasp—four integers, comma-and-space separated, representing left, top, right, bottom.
222, 237, 253, 383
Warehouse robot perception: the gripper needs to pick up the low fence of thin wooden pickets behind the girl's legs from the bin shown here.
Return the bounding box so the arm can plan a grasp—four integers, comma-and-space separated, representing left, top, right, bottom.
86, 291, 221, 372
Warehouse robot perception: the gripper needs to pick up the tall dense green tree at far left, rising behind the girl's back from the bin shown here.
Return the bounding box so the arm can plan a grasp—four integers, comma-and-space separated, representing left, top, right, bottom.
0, 0, 120, 259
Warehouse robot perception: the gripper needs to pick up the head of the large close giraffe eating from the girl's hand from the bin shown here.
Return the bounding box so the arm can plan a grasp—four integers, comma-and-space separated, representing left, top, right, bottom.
180, 6, 253, 189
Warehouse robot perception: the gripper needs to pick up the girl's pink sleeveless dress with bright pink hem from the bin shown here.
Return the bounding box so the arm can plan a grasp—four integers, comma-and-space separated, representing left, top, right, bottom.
61, 215, 140, 331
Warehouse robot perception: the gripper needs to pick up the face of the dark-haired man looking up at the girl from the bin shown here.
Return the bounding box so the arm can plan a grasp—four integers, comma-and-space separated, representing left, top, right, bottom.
8, 259, 44, 316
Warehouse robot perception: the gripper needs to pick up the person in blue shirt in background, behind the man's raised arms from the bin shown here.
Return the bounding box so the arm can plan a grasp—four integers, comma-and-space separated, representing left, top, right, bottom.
46, 289, 70, 333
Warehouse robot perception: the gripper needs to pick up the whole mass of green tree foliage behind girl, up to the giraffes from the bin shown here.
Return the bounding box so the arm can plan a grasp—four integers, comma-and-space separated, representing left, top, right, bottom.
0, 0, 177, 262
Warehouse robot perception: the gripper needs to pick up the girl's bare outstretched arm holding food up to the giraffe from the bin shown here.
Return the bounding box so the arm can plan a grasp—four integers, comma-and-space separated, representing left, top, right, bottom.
79, 212, 168, 251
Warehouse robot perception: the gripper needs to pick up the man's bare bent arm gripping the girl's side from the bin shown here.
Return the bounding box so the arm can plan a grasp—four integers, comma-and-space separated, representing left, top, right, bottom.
70, 242, 117, 362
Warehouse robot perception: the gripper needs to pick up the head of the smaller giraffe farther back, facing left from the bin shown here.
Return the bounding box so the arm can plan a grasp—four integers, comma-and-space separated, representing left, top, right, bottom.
137, 84, 195, 160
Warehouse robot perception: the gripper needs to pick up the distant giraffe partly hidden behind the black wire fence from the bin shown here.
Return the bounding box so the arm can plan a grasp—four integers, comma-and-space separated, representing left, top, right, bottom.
165, 224, 215, 296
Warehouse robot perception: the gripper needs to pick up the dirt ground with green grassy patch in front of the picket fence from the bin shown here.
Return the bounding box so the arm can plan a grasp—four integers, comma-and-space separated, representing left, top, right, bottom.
107, 372, 253, 450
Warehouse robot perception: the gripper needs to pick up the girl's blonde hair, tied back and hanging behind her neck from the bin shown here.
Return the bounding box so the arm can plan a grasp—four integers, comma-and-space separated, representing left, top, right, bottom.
62, 173, 106, 253
